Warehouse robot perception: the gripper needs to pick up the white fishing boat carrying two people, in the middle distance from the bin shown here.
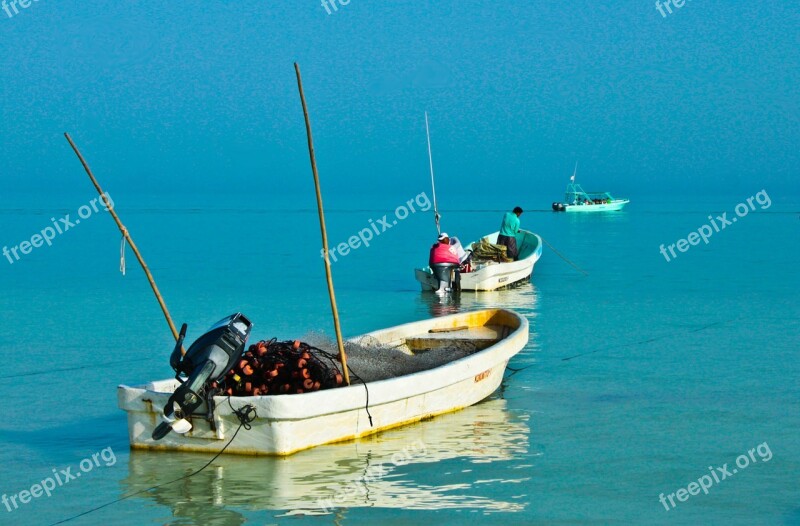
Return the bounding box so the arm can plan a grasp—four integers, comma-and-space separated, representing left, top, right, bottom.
414, 230, 542, 291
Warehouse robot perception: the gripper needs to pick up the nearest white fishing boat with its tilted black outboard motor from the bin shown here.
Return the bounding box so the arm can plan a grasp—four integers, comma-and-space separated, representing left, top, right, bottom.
118, 310, 524, 455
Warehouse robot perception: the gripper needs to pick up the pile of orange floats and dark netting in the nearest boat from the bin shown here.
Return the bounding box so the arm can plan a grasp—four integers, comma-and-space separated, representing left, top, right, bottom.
211, 338, 343, 396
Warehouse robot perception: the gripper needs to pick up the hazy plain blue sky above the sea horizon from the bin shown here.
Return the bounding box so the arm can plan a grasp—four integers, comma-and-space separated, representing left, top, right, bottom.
0, 0, 800, 207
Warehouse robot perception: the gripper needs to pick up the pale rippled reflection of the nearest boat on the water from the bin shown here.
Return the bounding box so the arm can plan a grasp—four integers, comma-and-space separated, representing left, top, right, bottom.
122, 399, 530, 525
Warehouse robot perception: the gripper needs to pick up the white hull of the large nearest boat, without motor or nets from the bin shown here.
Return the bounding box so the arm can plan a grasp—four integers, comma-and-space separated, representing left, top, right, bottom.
118, 309, 528, 455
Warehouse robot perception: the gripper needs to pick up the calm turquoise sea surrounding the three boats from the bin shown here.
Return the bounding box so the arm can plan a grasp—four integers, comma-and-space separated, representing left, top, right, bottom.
0, 192, 800, 525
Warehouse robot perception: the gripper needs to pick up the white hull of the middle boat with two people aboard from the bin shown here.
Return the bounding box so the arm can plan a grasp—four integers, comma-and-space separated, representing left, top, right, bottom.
414, 230, 542, 291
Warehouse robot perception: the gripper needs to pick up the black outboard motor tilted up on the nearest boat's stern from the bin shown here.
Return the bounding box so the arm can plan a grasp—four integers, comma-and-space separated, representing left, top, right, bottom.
153, 313, 253, 440
